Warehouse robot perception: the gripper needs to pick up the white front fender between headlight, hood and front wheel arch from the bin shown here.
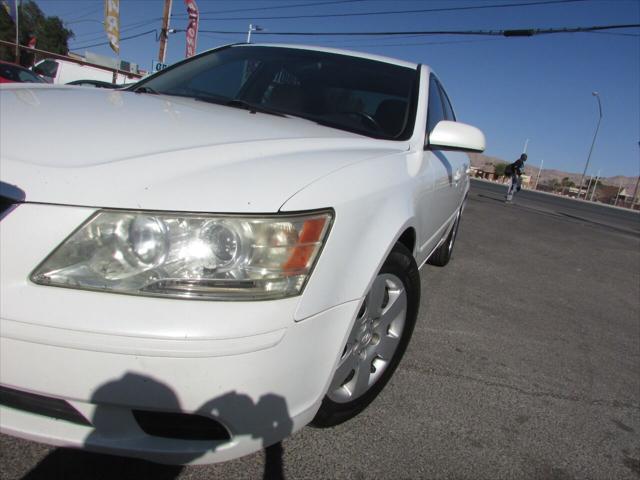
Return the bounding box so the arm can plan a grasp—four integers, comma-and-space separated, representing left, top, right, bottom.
281, 154, 418, 320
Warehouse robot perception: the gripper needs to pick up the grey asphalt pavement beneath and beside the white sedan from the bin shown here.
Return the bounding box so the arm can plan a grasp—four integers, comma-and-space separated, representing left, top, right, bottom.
0, 182, 640, 480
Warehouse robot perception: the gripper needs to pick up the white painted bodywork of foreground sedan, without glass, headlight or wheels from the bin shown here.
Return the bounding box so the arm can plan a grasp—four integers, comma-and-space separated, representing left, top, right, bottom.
0, 47, 484, 463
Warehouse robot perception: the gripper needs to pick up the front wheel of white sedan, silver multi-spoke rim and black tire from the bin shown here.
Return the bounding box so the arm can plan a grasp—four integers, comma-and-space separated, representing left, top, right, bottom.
312, 244, 420, 427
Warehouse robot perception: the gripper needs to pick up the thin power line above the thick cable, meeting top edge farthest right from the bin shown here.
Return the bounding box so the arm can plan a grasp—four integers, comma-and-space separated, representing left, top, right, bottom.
189, 0, 590, 22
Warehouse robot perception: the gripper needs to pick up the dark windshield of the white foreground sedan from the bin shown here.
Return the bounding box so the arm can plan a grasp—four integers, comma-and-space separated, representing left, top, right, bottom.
133, 46, 417, 139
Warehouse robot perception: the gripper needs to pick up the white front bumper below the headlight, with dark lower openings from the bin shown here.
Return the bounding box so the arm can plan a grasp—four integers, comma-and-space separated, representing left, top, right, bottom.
0, 205, 359, 463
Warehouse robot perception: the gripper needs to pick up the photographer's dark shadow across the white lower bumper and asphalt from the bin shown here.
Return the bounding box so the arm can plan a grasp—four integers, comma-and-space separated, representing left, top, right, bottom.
22, 373, 293, 480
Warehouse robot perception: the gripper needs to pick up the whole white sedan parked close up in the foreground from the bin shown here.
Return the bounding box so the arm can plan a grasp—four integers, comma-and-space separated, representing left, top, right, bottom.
0, 44, 484, 463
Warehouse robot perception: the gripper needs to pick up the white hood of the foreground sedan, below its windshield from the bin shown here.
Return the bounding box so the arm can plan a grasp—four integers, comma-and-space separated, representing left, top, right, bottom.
0, 85, 408, 213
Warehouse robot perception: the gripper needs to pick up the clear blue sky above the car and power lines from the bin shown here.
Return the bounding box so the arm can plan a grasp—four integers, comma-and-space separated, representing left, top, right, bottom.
36, 0, 640, 177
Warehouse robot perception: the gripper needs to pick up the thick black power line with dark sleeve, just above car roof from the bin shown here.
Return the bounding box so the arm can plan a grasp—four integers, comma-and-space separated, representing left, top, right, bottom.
194, 23, 640, 37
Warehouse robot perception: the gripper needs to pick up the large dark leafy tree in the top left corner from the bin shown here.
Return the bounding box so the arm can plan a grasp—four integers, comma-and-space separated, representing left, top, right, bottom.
0, 0, 74, 66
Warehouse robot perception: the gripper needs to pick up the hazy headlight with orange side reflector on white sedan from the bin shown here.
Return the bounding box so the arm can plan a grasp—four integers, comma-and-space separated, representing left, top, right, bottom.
31, 210, 332, 300
